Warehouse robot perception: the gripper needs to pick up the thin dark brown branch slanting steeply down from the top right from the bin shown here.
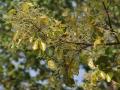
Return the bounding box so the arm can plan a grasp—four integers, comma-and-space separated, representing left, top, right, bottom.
102, 1, 119, 42
